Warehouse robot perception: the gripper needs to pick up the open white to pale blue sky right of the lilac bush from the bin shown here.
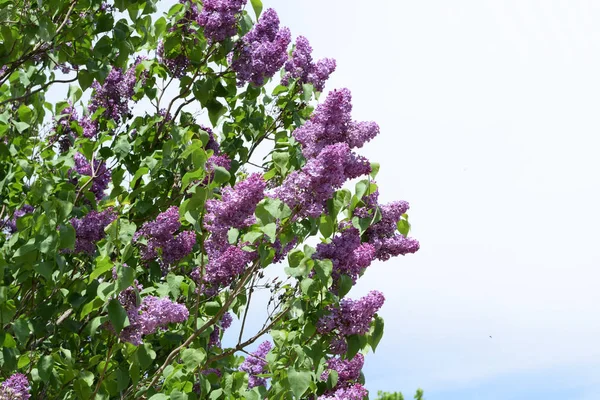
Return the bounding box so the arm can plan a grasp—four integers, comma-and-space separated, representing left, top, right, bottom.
263, 0, 600, 400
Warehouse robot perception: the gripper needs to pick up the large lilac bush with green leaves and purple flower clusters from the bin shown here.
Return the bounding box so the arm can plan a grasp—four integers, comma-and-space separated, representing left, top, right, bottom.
0, 0, 419, 400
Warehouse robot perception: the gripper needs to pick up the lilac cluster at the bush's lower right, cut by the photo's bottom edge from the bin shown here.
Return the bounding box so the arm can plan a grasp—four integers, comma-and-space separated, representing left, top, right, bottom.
319, 353, 368, 400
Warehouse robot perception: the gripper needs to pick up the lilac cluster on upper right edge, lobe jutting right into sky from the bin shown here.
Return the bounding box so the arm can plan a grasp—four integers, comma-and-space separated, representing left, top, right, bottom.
294, 89, 379, 158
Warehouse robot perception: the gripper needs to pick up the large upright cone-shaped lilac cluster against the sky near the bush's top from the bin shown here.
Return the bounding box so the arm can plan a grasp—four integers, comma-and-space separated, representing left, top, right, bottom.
231, 8, 291, 86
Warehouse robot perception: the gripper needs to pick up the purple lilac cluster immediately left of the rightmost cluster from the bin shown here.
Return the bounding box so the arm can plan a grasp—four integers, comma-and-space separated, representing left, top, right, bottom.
313, 226, 375, 283
